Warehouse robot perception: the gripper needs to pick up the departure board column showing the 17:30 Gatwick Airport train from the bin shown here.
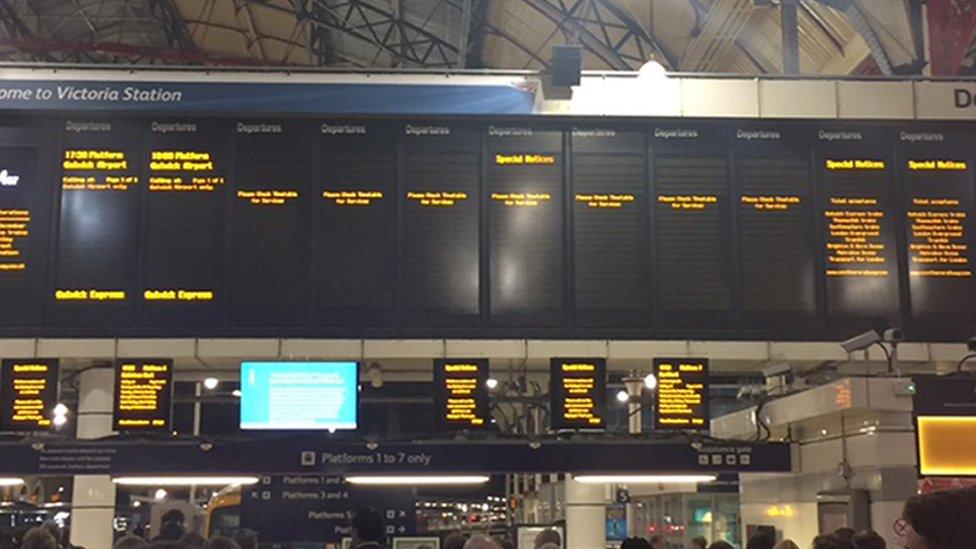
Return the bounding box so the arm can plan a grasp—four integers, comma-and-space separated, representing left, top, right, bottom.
50, 119, 144, 326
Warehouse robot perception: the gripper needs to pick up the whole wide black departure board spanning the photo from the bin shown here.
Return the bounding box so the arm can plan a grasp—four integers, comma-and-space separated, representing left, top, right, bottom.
0, 112, 976, 341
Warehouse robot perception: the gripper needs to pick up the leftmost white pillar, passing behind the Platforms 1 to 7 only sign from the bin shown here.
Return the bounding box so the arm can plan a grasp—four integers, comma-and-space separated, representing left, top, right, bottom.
71, 368, 115, 547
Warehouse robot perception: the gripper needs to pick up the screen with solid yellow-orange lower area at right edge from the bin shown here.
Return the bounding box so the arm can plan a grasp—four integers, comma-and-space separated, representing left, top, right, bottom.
914, 375, 976, 477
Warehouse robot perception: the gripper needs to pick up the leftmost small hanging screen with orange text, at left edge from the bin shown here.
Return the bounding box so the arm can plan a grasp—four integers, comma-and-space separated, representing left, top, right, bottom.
0, 359, 58, 432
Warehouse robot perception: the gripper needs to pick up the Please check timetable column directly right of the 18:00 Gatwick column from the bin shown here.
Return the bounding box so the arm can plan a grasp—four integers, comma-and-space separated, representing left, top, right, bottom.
228, 121, 317, 326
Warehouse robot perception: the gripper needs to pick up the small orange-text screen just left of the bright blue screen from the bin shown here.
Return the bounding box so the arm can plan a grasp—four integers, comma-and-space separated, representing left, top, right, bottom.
112, 358, 173, 432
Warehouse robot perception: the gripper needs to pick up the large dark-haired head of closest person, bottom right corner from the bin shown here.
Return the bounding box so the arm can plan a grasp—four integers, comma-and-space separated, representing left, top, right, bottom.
894, 488, 976, 549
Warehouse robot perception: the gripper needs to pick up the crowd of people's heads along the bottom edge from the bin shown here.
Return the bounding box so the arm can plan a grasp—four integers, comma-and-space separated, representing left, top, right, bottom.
5, 489, 976, 549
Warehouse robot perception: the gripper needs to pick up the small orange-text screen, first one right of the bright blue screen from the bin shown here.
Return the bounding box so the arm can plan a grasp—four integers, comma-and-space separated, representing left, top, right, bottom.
434, 359, 491, 429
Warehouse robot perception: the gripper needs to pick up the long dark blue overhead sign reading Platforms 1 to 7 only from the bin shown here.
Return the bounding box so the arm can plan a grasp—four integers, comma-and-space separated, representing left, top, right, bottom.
0, 438, 791, 476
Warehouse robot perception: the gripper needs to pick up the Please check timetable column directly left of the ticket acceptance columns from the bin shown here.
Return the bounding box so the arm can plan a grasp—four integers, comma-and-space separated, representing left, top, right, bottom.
732, 124, 819, 329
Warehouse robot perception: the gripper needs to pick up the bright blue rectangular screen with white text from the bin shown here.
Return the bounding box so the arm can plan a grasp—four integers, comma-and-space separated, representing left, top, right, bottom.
241, 362, 359, 429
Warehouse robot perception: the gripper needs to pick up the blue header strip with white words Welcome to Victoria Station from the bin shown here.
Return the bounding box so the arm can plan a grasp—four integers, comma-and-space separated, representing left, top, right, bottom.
0, 80, 535, 114
